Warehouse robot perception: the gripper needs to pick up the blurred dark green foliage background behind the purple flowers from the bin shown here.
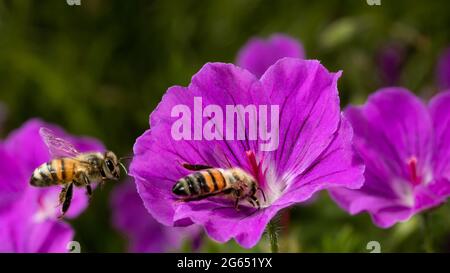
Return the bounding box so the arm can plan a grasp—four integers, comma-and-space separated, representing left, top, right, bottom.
0, 0, 450, 252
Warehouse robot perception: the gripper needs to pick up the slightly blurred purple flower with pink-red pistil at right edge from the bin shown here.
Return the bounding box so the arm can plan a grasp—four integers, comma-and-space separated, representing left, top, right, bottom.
331, 88, 450, 228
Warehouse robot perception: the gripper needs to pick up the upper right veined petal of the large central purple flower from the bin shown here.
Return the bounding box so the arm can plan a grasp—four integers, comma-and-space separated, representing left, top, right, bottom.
261, 59, 340, 186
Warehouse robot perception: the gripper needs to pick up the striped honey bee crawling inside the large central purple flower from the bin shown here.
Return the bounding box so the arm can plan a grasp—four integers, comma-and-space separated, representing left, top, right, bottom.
172, 163, 266, 210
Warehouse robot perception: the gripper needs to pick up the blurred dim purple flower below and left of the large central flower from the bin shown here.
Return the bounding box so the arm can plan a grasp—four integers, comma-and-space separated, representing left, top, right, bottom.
111, 182, 199, 252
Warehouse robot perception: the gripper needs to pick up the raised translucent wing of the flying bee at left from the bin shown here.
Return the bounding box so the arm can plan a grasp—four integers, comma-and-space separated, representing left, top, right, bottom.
39, 127, 80, 158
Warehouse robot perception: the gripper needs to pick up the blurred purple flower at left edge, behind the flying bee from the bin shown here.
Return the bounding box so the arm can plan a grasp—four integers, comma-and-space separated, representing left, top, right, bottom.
0, 119, 103, 252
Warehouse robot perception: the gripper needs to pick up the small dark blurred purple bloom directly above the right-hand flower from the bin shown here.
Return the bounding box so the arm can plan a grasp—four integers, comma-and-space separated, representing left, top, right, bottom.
377, 43, 405, 86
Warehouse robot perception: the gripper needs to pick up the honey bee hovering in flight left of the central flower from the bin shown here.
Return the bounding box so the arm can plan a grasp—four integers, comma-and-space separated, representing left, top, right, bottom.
30, 128, 126, 218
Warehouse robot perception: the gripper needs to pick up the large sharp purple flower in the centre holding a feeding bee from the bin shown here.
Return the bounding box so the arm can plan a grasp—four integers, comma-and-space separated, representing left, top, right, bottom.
130, 58, 364, 248
